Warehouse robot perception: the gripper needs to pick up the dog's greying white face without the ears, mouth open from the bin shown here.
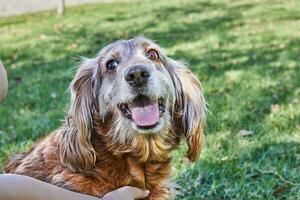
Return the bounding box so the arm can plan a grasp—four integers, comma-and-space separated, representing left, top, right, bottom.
98, 38, 176, 140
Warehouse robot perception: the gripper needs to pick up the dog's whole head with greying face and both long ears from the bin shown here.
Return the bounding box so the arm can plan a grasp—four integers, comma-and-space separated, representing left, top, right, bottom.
61, 37, 206, 172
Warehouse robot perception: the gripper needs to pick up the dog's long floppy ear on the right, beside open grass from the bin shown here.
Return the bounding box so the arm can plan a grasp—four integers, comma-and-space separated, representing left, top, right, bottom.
167, 59, 206, 162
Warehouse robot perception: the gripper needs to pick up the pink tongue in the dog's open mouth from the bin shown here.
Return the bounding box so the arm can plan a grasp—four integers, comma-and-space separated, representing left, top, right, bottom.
131, 103, 159, 126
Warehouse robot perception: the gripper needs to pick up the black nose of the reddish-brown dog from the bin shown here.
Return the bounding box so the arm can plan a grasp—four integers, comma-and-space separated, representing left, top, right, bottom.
125, 65, 150, 87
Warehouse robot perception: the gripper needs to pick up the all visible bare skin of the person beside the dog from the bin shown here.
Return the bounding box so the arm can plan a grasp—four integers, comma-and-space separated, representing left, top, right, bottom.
0, 61, 149, 200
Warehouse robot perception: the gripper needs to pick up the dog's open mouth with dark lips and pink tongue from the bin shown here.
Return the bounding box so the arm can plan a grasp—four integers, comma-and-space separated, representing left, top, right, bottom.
118, 95, 165, 129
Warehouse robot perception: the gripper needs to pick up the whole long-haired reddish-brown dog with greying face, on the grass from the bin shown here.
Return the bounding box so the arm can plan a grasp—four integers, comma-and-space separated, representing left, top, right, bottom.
4, 37, 206, 200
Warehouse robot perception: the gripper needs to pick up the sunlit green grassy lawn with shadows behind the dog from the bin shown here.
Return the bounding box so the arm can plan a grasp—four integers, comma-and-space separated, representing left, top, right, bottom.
0, 0, 300, 200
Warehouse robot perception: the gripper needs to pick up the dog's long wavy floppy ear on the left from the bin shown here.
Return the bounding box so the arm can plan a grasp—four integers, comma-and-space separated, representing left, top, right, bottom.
60, 60, 97, 171
